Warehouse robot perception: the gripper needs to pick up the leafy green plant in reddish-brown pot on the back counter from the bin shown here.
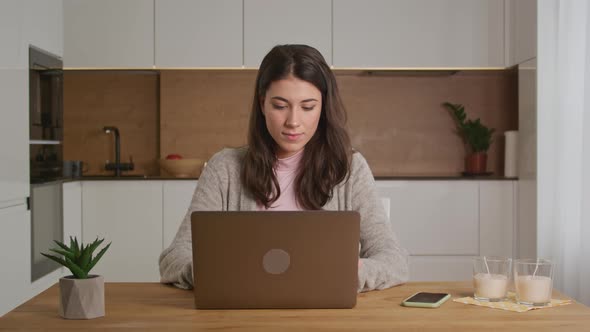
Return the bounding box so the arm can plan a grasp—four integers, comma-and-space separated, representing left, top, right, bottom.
443, 102, 495, 174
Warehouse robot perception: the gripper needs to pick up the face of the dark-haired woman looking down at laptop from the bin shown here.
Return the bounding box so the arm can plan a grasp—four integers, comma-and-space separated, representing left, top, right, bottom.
262, 75, 322, 158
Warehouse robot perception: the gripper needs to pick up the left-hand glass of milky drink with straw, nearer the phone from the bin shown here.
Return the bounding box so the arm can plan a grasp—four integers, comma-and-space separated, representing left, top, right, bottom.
473, 256, 512, 302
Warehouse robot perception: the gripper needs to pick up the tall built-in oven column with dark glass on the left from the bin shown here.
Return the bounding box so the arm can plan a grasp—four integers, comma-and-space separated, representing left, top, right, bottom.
29, 46, 63, 281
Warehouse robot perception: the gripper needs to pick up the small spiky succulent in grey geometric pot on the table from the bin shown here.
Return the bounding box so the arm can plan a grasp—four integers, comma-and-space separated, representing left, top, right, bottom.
41, 237, 111, 319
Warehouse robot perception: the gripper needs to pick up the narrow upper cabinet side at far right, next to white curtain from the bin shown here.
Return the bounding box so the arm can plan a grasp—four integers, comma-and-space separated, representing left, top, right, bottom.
506, 0, 537, 66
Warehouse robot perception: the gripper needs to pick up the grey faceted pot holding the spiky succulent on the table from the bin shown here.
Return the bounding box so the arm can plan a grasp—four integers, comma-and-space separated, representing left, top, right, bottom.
59, 275, 104, 319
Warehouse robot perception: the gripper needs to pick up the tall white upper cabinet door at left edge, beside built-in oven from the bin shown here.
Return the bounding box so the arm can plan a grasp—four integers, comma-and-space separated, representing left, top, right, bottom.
0, 0, 29, 208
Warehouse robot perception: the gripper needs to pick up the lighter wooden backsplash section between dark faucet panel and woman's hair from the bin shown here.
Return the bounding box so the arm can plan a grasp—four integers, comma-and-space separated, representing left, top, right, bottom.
160, 70, 256, 160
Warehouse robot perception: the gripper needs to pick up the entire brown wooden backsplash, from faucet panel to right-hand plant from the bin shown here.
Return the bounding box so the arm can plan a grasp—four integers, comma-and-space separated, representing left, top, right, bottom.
64, 70, 518, 176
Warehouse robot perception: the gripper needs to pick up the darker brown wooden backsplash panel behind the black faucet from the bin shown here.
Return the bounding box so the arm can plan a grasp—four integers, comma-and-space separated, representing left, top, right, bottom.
64, 71, 159, 174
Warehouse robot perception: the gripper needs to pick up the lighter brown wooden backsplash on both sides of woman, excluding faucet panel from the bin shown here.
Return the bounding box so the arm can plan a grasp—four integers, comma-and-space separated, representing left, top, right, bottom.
160, 71, 518, 176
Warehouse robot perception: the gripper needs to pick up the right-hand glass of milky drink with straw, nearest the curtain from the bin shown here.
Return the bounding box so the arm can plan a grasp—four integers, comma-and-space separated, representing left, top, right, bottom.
514, 259, 553, 306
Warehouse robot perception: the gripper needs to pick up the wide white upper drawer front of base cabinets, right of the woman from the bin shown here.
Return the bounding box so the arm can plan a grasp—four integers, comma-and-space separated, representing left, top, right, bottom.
377, 180, 479, 256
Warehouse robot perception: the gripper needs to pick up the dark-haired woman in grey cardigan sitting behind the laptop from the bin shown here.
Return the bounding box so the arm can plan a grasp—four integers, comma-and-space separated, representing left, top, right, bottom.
160, 45, 408, 291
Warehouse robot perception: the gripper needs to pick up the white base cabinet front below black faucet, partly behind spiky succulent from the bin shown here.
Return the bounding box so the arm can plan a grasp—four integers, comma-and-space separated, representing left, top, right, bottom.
82, 180, 162, 282
